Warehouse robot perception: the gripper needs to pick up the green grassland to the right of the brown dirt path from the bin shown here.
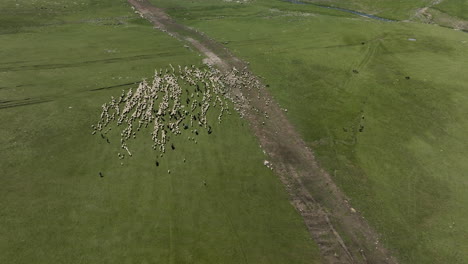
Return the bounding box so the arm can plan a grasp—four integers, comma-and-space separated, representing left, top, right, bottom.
152, 0, 468, 264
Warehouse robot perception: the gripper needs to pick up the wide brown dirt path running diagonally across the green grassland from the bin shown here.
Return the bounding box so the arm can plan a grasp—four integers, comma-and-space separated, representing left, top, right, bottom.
128, 0, 397, 263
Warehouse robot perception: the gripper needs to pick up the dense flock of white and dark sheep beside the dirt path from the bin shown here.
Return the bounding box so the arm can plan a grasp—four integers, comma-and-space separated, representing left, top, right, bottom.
92, 65, 260, 159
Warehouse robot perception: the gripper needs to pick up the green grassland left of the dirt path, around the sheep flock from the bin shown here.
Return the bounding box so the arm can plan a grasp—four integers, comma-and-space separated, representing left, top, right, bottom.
0, 0, 320, 264
